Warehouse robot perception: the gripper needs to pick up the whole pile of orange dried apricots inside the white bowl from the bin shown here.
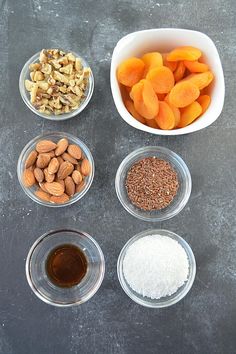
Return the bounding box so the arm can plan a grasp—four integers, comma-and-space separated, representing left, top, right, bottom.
117, 46, 214, 130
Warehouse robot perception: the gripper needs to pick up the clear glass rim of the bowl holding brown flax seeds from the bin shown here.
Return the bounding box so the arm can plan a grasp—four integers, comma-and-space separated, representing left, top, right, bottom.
115, 146, 192, 222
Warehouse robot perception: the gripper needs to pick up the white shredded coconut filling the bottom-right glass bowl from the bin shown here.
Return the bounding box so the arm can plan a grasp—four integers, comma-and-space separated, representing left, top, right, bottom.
123, 235, 189, 299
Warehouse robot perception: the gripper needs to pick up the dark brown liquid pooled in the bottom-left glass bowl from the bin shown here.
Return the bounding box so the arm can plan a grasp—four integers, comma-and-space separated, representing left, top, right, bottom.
46, 245, 87, 288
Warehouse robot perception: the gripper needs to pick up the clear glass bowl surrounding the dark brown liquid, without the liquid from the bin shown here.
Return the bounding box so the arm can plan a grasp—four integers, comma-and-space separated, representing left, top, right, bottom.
25, 229, 105, 307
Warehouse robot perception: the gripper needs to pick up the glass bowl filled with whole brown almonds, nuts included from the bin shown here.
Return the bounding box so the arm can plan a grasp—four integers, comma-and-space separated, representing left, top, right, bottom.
17, 132, 94, 207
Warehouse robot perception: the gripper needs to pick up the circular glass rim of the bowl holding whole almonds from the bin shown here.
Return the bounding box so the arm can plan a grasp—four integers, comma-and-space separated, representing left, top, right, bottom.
17, 131, 95, 208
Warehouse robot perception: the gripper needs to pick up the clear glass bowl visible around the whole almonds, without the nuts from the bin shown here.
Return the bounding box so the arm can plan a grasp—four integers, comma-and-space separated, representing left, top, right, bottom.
17, 132, 95, 208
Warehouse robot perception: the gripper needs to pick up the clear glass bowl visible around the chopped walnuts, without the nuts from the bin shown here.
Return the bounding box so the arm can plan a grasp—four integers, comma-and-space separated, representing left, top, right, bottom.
19, 51, 94, 121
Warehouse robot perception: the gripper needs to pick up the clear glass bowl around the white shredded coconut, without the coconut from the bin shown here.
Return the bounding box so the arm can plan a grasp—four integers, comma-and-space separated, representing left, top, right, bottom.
117, 230, 196, 308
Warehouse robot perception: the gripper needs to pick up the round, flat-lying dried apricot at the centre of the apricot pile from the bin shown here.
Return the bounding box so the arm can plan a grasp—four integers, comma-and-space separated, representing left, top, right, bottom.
146, 66, 175, 93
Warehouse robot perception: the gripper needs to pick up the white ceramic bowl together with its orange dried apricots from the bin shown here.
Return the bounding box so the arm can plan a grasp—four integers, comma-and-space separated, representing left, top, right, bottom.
110, 28, 225, 135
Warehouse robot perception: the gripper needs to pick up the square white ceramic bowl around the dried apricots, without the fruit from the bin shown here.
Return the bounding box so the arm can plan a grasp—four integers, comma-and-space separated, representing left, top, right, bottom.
110, 28, 225, 135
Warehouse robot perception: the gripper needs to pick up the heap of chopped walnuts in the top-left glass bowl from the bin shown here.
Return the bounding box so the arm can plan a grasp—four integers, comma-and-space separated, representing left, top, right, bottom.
25, 49, 91, 115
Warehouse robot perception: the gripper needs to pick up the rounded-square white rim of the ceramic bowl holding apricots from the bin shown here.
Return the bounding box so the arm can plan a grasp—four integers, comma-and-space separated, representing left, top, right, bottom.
110, 28, 225, 136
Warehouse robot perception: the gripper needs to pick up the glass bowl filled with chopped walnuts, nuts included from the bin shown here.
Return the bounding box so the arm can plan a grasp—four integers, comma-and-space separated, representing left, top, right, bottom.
19, 49, 94, 120
